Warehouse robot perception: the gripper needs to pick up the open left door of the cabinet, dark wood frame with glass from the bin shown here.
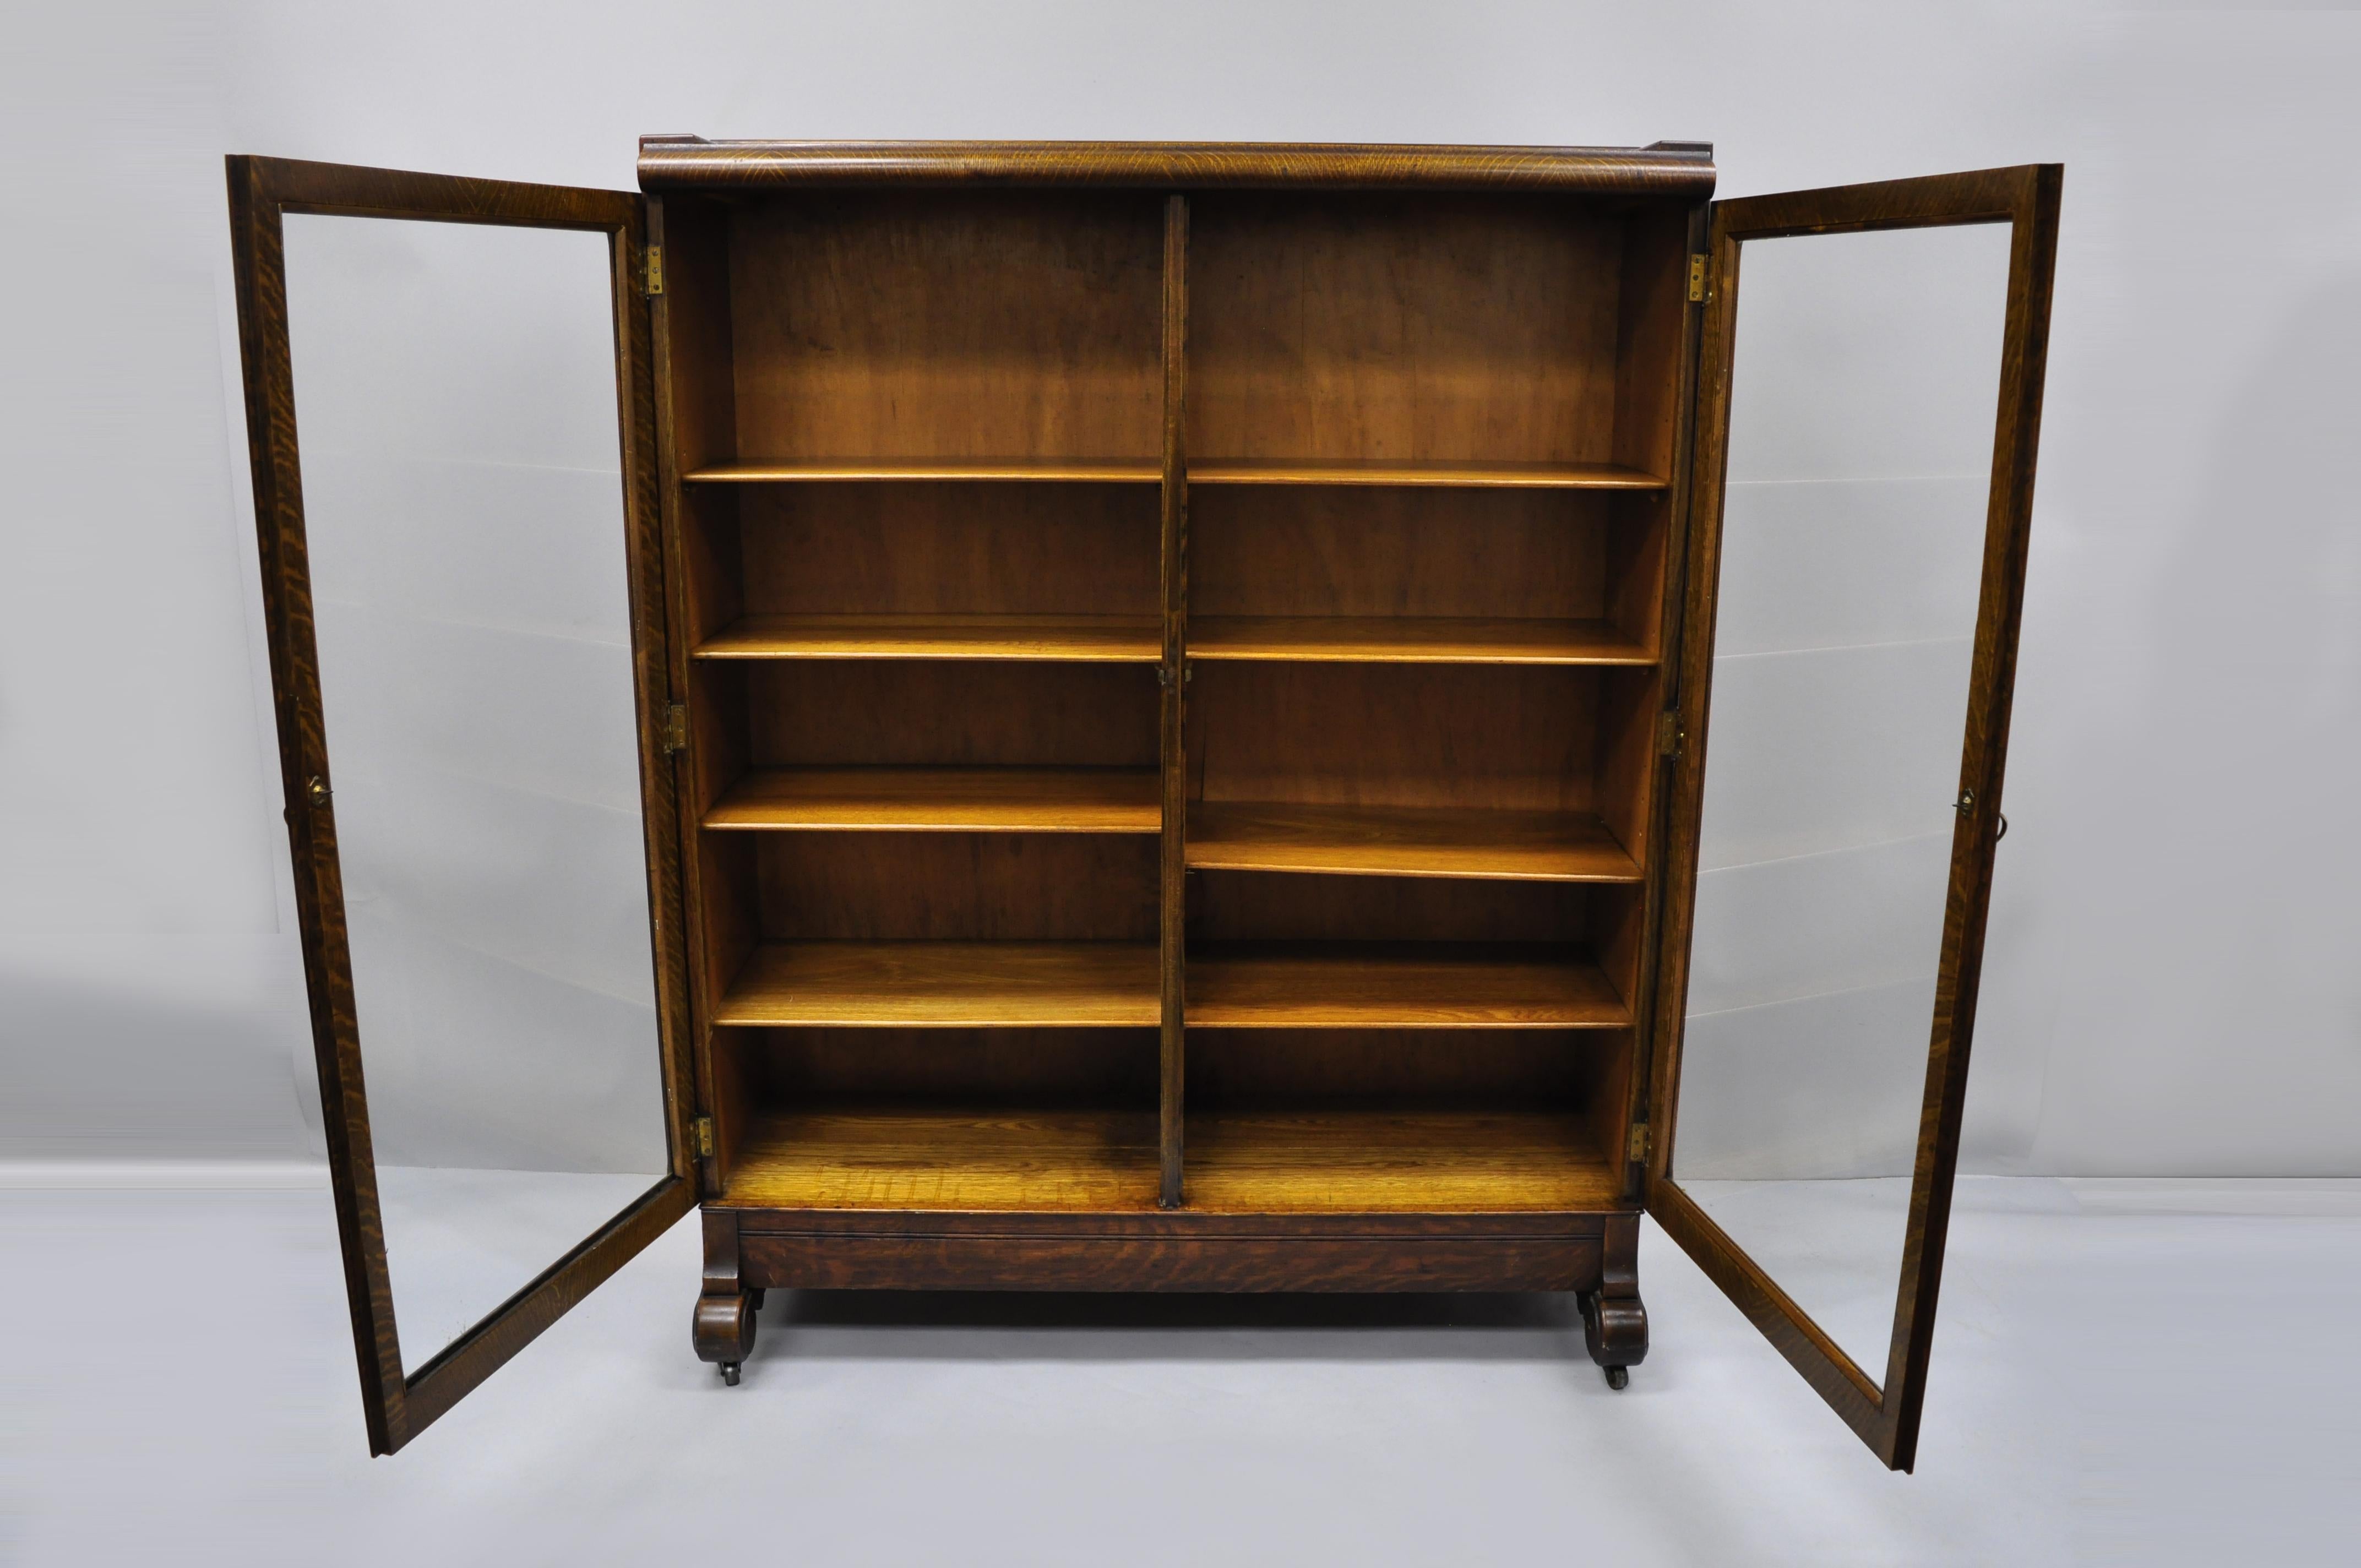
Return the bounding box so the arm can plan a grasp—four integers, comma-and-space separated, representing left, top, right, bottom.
229, 158, 697, 1455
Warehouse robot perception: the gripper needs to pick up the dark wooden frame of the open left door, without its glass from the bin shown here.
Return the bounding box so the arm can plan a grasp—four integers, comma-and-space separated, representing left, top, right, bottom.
227, 156, 697, 1455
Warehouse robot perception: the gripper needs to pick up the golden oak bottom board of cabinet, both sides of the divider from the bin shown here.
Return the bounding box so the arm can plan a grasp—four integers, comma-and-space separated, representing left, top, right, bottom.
715, 1105, 1622, 1214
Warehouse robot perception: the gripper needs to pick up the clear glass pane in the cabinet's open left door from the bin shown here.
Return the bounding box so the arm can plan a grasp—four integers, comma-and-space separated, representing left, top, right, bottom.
286, 215, 666, 1372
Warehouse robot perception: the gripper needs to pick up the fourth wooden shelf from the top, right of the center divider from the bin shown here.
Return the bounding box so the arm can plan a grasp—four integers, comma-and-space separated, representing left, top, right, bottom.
1185, 942, 1631, 1030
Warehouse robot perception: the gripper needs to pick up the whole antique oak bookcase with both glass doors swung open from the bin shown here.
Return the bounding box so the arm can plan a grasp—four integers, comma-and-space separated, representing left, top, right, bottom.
229, 137, 2061, 1469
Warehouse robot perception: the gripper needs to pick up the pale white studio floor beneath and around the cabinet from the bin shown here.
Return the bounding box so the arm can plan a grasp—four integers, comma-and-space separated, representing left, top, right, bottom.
0, 1167, 2361, 1568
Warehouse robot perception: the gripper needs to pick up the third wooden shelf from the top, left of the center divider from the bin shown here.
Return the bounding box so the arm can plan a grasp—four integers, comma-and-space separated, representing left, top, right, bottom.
706, 767, 1164, 834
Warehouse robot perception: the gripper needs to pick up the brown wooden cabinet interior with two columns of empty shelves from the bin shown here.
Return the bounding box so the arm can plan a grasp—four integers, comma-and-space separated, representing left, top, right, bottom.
661, 189, 1690, 1214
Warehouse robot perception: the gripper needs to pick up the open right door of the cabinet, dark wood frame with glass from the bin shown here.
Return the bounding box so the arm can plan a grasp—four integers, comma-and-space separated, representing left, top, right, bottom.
1648, 165, 2061, 1469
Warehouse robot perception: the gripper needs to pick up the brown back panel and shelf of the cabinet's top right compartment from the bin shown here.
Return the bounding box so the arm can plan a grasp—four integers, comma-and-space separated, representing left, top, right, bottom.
1188, 194, 1657, 472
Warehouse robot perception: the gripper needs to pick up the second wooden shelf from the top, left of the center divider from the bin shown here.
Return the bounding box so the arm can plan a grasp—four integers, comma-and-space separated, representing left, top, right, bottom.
697, 616, 1164, 663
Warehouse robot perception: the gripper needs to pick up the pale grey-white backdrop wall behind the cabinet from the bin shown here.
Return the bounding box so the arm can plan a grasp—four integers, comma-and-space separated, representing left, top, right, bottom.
0, 0, 2361, 1176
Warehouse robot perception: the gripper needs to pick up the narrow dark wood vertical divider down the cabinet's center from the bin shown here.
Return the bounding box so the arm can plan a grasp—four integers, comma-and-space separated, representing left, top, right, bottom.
1157, 194, 1188, 1209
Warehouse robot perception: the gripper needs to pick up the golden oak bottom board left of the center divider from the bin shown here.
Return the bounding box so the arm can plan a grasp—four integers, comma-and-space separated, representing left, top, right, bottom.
715, 1105, 1157, 1209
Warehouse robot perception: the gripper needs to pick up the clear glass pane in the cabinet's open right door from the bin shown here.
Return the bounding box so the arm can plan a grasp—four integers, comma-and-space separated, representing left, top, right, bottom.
1674, 224, 2009, 1379
